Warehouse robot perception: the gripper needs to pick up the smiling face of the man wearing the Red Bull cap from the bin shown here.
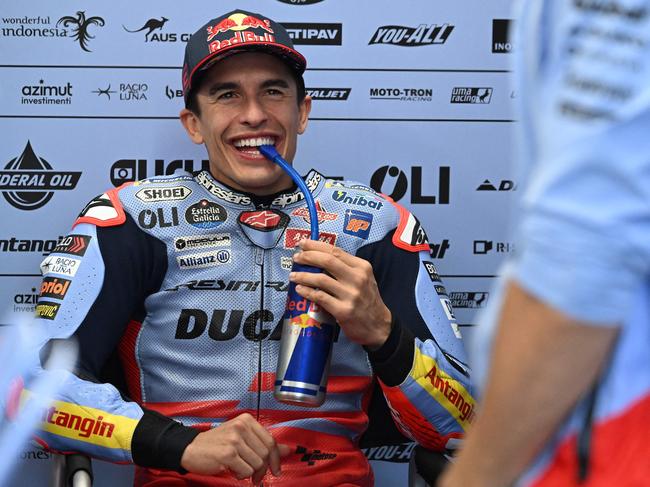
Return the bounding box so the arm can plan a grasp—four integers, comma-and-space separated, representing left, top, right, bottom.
181, 52, 311, 195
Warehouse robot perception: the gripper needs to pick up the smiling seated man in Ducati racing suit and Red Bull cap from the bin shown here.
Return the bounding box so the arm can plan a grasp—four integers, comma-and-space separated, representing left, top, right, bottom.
31, 11, 474, 487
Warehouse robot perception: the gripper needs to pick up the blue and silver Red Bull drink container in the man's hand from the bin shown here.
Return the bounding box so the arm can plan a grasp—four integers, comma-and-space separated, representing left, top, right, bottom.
274, 263, 338, 407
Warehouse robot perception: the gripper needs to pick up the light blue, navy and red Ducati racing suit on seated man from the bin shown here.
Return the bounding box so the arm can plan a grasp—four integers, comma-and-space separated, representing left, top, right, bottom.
36, 171, 474, 487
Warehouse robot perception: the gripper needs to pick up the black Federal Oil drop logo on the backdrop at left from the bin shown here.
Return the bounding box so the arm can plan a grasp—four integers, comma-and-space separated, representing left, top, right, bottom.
0, 141, 81, 210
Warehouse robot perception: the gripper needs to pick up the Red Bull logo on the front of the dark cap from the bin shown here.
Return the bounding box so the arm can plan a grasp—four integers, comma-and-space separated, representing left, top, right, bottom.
207, 13, 275, 53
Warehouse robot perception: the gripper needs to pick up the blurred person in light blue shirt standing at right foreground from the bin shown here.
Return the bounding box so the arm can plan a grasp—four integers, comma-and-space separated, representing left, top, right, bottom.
438, 0, 650, 487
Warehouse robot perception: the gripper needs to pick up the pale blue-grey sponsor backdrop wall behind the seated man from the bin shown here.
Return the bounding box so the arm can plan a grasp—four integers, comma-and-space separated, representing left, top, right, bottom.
0, 0, 517, 486
